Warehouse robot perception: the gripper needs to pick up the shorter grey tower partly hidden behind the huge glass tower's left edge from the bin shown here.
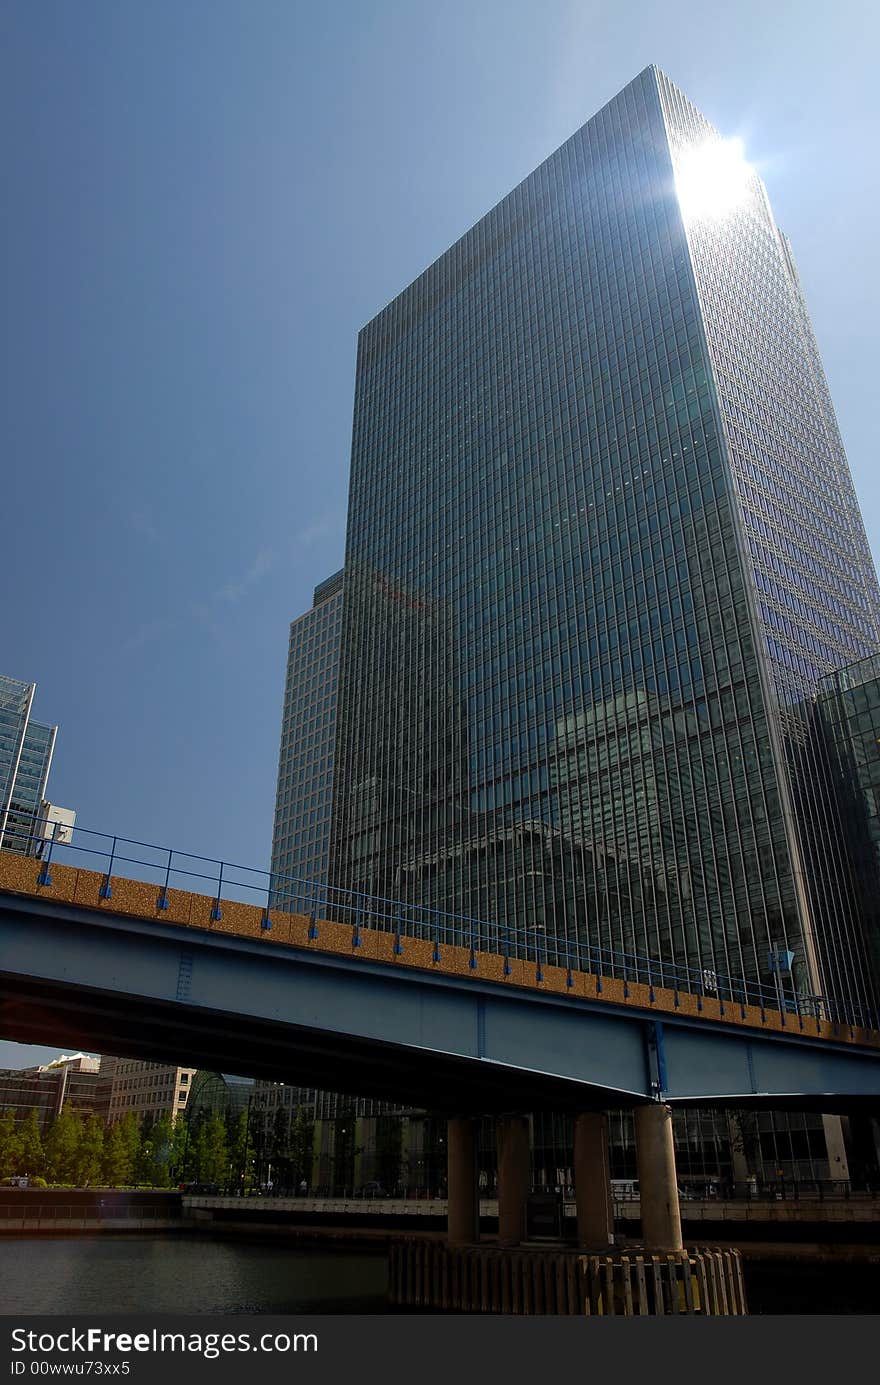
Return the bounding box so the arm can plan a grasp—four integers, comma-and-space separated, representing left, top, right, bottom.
272, 572, 342, 909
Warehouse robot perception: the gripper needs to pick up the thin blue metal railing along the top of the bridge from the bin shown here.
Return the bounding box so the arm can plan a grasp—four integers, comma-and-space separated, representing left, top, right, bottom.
8, 825, 880, 1032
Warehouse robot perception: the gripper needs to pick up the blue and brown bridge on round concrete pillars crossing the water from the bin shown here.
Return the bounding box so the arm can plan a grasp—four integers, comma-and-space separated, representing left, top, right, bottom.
0, 838, 880, 1263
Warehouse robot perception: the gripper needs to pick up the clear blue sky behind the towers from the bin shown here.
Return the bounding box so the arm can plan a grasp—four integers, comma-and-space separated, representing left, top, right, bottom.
0, 0, 880, 1065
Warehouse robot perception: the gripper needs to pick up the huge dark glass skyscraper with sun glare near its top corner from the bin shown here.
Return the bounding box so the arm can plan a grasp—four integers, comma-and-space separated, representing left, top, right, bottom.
331, 66, 880, 1019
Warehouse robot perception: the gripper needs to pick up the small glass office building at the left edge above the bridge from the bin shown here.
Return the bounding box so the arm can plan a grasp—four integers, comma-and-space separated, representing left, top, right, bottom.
0, 674, 76, 856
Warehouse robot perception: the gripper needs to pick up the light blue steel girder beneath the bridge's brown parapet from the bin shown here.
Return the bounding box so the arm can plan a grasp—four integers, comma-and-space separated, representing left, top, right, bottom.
0, 892, 880, 1112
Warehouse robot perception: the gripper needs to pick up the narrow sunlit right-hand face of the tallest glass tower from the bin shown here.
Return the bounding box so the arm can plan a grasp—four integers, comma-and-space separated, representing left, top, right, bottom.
658, 78, 880, 1008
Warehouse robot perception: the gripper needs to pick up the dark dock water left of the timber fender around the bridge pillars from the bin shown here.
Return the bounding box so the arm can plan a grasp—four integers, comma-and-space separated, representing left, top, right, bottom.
0, 1231, 388, 1313
